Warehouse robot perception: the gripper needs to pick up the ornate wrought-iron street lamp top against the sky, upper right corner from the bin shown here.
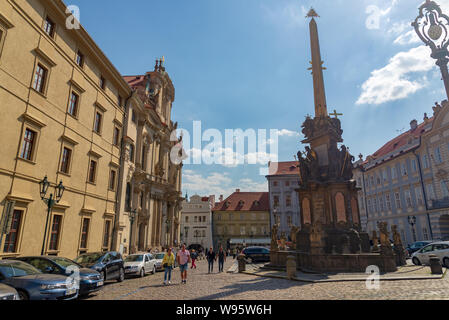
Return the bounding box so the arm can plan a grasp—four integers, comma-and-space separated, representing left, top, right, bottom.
412, 0, 449, 99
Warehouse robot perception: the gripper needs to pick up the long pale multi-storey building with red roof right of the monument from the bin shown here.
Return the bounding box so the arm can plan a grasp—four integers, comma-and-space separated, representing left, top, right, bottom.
354, 102, 449, 244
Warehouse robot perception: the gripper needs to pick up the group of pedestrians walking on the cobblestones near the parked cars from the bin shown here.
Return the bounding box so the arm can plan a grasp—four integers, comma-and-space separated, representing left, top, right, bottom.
162, 244, 229, 285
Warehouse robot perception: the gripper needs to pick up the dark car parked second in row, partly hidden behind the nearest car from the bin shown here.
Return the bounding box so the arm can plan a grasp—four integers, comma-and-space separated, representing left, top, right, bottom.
17, 256, 104, 296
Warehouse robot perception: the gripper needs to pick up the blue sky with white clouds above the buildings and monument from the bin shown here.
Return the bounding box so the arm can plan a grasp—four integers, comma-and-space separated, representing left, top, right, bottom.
65, 0, 449, 196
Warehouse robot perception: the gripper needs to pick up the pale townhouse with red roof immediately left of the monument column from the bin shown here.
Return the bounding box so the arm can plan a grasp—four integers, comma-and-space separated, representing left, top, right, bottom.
266, 161, 301, 236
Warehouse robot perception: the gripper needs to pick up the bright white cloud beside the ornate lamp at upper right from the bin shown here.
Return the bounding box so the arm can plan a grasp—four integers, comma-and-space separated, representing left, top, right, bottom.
356, 46, 435, 105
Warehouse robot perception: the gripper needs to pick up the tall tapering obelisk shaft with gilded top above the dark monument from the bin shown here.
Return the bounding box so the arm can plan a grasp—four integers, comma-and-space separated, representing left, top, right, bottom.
307, 9, 328, 117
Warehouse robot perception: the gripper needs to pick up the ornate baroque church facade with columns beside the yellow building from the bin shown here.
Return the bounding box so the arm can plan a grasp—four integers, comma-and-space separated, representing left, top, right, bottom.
115, 60, 183, 254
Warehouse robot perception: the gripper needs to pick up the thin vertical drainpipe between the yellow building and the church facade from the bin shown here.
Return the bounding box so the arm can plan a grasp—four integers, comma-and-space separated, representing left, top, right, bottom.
111, 92, 133, 254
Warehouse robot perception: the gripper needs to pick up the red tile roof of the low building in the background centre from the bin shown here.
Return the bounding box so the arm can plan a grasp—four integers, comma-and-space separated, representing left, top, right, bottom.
212, 192, 270, 211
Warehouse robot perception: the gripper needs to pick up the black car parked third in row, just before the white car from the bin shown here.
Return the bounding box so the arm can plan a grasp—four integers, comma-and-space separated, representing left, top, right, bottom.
75, 251, 125, 282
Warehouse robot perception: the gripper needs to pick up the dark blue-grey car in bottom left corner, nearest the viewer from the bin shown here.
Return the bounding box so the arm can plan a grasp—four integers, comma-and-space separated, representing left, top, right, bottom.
0, 260, 78, 300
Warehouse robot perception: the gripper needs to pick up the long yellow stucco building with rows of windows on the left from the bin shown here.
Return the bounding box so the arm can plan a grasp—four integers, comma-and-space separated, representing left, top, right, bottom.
0, 0, 131, 258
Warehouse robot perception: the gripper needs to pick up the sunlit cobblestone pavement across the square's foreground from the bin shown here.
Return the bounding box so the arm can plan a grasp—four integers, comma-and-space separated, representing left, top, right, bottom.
88, 258, 449, 300
